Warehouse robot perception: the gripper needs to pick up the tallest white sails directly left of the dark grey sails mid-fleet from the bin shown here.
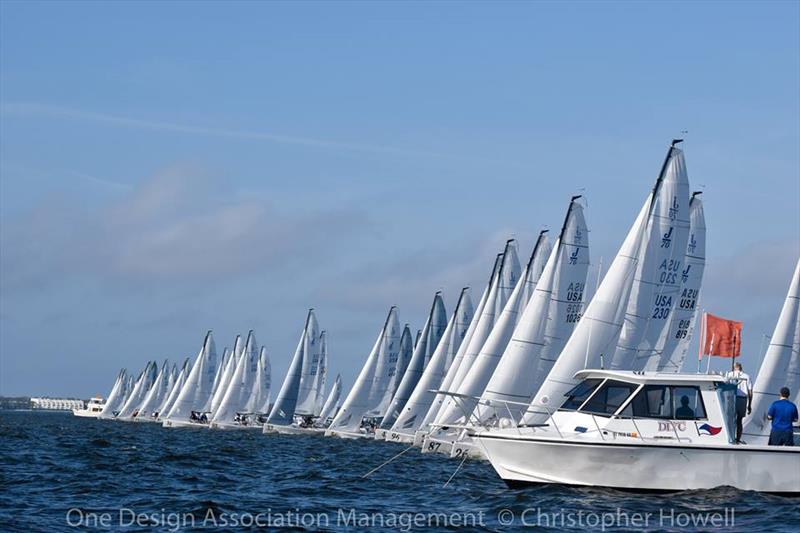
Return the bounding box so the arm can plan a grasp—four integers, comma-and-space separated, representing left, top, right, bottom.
326, 306, 400, 435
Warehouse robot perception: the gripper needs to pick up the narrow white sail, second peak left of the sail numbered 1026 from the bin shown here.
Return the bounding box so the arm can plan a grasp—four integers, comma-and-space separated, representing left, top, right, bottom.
434, 239, 524, 425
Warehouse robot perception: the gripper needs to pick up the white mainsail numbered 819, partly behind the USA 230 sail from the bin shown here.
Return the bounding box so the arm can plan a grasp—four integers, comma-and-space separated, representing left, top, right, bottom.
644, 192, 706, 372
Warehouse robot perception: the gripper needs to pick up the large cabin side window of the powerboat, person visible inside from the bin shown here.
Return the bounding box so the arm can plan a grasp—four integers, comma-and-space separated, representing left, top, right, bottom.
620, 385, 706, 420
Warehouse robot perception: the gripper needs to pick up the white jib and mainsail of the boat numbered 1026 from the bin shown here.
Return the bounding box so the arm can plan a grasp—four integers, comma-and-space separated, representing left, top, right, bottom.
476, 197, 589, 422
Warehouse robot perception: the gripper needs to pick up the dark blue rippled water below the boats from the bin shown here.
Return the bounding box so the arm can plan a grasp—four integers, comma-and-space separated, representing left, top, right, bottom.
0, 412, 800, 532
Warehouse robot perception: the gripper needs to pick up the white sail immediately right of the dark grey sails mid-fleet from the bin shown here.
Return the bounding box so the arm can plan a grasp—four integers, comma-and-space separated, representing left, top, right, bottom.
392, 287, 473, 434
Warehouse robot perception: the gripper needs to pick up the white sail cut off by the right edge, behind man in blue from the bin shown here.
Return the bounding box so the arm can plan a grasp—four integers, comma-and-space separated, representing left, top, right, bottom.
743, 260, 800, 444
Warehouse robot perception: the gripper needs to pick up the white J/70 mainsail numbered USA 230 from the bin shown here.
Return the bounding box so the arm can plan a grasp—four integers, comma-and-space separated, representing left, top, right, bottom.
611, 145, 689, 370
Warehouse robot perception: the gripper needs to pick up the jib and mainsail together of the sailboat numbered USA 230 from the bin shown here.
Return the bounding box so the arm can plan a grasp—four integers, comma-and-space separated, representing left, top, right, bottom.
524, 140, 688, 424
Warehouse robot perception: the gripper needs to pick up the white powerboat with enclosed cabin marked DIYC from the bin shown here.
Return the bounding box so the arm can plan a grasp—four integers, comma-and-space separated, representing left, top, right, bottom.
472, 370, 800, 495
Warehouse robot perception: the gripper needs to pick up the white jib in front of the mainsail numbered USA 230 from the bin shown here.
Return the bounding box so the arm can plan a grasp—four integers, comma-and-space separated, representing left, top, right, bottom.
524, 140, 688, 424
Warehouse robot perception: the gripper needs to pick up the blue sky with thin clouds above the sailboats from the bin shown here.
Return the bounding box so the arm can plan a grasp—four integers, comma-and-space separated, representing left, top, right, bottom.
0, 1, 800, 397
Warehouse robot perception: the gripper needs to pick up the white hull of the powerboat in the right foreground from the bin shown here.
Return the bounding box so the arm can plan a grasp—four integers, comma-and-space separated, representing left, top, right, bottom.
475, 434, 800, 495
